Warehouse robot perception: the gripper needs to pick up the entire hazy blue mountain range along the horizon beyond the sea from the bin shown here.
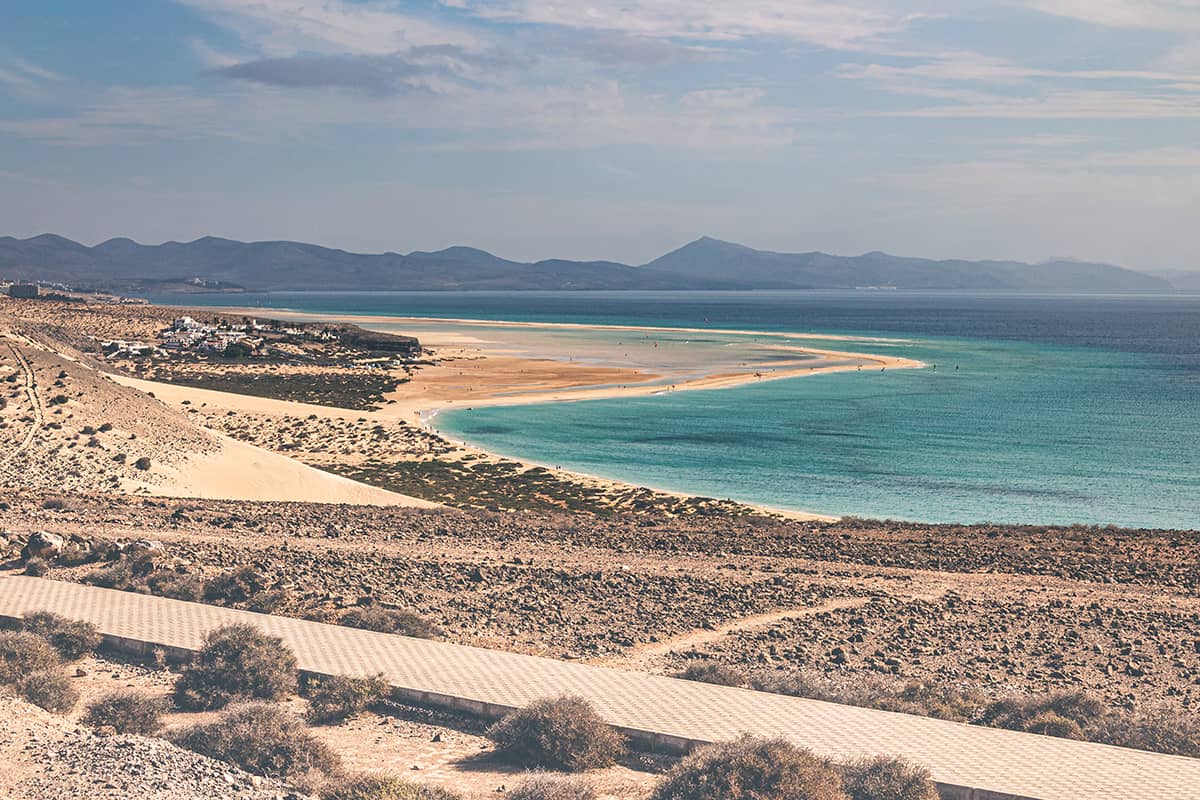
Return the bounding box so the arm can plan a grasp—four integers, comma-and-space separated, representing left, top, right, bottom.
0, 234, 1172, 293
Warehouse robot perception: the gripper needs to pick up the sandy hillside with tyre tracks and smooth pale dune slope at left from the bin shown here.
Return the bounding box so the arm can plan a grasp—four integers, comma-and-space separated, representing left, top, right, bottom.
0, 320, 432, 506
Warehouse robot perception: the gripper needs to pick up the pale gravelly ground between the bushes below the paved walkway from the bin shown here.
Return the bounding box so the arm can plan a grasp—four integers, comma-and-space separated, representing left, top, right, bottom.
0, 655, 668, 800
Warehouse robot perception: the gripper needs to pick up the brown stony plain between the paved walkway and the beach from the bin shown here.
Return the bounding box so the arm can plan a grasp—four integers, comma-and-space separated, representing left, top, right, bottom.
4, 497, 1200, 708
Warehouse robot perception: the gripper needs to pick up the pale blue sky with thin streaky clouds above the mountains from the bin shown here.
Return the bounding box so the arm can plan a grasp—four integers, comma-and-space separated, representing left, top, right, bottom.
0, 0, 1200, 269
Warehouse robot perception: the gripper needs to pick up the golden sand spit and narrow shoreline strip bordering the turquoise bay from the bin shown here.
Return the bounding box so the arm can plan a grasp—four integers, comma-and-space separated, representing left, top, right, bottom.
115, 303, 925, 521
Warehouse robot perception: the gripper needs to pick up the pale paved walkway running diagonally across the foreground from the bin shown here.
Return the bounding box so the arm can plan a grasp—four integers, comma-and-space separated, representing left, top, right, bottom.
0, 576, 1200, 800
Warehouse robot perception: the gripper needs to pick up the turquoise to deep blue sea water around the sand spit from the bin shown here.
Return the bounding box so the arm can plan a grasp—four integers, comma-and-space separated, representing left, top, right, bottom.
162, 291, 1200, 528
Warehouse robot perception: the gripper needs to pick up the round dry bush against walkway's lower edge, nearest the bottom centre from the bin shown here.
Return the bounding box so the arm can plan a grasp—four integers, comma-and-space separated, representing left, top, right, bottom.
487, 697, 625, 772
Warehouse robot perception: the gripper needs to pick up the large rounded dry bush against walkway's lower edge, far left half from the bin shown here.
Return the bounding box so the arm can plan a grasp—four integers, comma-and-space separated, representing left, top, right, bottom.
175, 625, 298, 710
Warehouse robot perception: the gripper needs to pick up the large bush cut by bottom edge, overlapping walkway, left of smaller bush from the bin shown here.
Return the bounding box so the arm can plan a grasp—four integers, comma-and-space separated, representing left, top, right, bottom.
652, 736, 847, 800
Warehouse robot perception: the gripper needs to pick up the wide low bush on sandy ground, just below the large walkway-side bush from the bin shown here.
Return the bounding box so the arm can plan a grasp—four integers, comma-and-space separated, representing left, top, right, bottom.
168, 703, 340, 778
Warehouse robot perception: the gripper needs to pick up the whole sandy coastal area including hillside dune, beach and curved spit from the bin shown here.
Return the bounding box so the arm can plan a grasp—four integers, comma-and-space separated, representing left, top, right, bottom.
0, 297, 924, 519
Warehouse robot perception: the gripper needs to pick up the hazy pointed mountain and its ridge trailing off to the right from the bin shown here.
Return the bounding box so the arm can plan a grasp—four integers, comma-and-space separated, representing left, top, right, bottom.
646, 237, 1172, 291
